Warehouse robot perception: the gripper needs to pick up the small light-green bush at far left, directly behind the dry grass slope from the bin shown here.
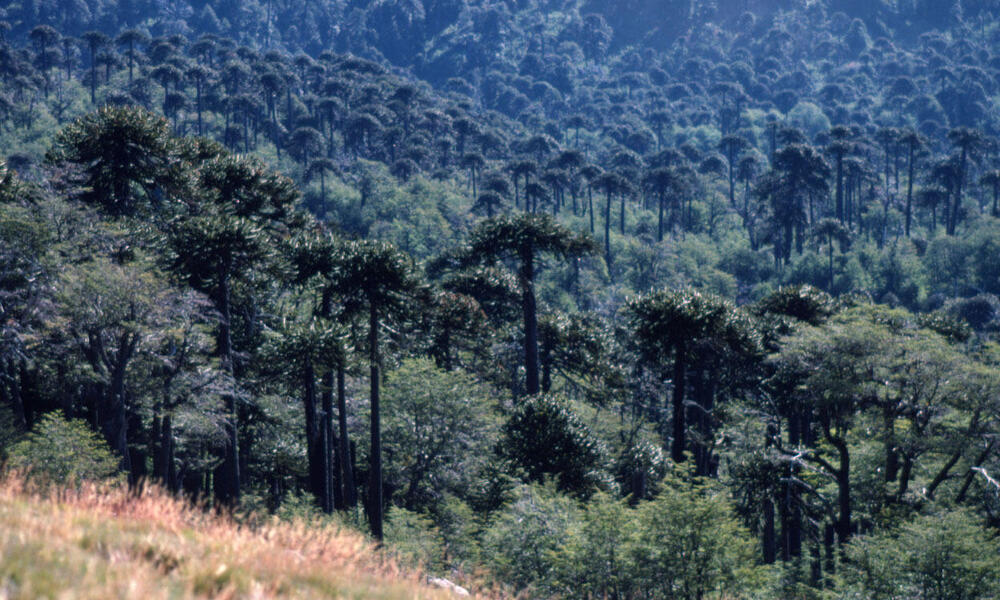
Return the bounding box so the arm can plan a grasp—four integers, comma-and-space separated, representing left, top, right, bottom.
7, 413, 119, 486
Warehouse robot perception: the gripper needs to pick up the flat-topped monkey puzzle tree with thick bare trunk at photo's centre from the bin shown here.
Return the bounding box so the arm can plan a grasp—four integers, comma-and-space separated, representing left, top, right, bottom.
467, 213, 596, 394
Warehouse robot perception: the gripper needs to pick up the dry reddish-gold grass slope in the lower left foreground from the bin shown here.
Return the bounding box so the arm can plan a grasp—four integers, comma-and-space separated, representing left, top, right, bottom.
0, 477, 460, 600
